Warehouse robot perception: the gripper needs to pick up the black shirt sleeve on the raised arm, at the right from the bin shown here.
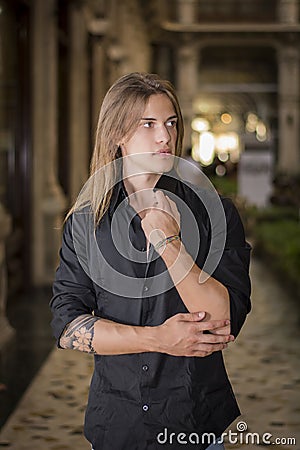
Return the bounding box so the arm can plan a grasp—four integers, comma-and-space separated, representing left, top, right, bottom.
213, 198, 251, 336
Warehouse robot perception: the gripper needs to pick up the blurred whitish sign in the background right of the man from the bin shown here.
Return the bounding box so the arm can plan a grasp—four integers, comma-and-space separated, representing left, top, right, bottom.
238, 150, 274, 207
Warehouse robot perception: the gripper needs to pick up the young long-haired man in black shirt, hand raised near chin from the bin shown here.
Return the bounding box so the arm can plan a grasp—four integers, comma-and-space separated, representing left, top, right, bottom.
51, 73, 250, 450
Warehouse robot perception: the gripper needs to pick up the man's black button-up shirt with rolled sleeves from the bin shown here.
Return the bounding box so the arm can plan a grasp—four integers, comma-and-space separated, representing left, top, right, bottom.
51, 171, 250, 450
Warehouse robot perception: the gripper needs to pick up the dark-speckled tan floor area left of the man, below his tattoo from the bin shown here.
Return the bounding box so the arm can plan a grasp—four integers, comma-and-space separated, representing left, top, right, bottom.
0, 349, 92, 450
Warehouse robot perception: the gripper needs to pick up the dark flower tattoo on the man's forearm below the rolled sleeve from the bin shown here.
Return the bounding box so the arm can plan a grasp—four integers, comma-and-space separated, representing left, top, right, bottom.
59, 314, 100, 353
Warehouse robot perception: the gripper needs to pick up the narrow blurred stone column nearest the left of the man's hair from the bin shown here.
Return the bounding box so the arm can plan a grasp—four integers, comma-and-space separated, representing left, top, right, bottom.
69, 2, 92, 202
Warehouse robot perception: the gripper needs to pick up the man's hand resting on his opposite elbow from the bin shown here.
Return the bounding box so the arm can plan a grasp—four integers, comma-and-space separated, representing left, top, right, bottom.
158, 312, 234, 357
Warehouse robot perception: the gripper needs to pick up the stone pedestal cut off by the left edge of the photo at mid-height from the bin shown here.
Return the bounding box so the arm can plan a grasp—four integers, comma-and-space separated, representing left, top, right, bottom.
0, 203, 14, 353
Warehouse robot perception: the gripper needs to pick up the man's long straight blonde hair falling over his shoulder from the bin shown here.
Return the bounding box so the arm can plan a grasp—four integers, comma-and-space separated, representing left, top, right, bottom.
67, 72, 184, 225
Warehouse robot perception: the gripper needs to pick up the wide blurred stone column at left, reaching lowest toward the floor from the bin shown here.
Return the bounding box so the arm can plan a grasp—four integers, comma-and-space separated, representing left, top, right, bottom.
32, 0, 66, 285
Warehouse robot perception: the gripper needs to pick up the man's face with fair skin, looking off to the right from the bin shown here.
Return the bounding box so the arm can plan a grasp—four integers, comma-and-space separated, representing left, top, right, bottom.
121, 94, 177, 174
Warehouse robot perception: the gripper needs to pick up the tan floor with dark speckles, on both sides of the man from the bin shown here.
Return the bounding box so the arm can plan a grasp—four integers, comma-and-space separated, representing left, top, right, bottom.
0, 258, 300, 450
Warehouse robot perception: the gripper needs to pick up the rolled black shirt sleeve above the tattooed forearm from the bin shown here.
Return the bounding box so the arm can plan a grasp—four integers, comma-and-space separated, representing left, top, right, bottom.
50, 216, 96, 347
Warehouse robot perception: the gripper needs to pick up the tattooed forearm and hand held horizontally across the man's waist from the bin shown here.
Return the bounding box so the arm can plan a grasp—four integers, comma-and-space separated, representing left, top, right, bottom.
60, 312, 233, 357
